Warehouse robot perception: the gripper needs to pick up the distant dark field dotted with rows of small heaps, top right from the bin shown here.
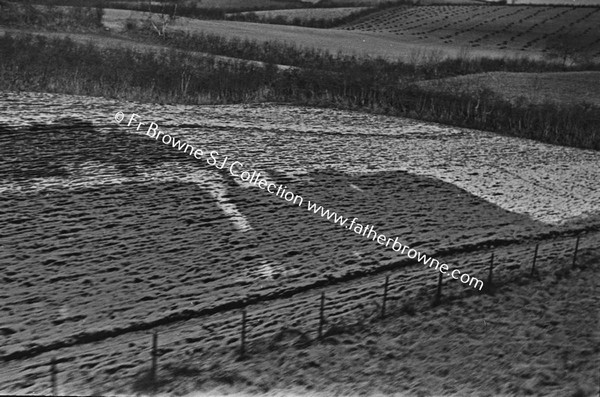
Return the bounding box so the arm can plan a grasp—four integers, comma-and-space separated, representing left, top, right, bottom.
343, 5, 600, 56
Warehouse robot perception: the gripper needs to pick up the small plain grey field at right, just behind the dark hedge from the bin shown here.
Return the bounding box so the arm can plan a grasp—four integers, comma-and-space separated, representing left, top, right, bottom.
419, 72, 600, 106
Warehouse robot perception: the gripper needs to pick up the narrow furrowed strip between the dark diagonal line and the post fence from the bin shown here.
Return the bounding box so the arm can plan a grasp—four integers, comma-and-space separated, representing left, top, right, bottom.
0, 232, 600, 391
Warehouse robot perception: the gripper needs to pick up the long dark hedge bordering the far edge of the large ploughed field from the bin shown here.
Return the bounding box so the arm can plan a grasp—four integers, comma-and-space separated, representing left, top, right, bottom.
0, 31, 600, 150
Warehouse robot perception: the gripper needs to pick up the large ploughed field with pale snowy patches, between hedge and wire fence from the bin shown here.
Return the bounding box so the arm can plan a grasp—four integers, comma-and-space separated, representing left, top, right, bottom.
0, 93, 600, 393
